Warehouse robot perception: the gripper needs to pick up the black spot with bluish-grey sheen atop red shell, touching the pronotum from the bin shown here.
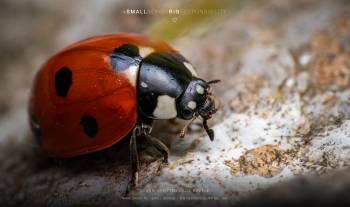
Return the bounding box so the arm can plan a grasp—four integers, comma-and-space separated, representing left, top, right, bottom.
110, 44, 141, 71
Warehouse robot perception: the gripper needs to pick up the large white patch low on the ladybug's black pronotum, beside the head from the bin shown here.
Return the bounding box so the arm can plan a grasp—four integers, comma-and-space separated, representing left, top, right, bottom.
153, 95, 177, 119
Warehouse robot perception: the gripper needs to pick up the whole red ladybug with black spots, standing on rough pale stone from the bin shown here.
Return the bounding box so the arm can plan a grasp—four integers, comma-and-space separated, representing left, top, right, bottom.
29, 34, 218, 185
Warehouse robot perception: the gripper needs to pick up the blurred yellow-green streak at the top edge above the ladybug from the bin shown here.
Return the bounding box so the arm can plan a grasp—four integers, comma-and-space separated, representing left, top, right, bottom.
146, 0, 265, 40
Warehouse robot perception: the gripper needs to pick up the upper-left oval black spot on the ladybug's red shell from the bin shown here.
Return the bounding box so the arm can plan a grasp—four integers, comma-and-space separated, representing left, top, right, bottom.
55, 67, 72, 97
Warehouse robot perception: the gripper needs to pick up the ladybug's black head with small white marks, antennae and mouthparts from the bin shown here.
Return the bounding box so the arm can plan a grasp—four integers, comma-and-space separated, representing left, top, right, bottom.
176, 79, 219, 140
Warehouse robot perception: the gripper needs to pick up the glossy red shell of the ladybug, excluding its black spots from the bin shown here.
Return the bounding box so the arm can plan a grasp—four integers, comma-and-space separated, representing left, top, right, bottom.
29, 34, 174, 157
